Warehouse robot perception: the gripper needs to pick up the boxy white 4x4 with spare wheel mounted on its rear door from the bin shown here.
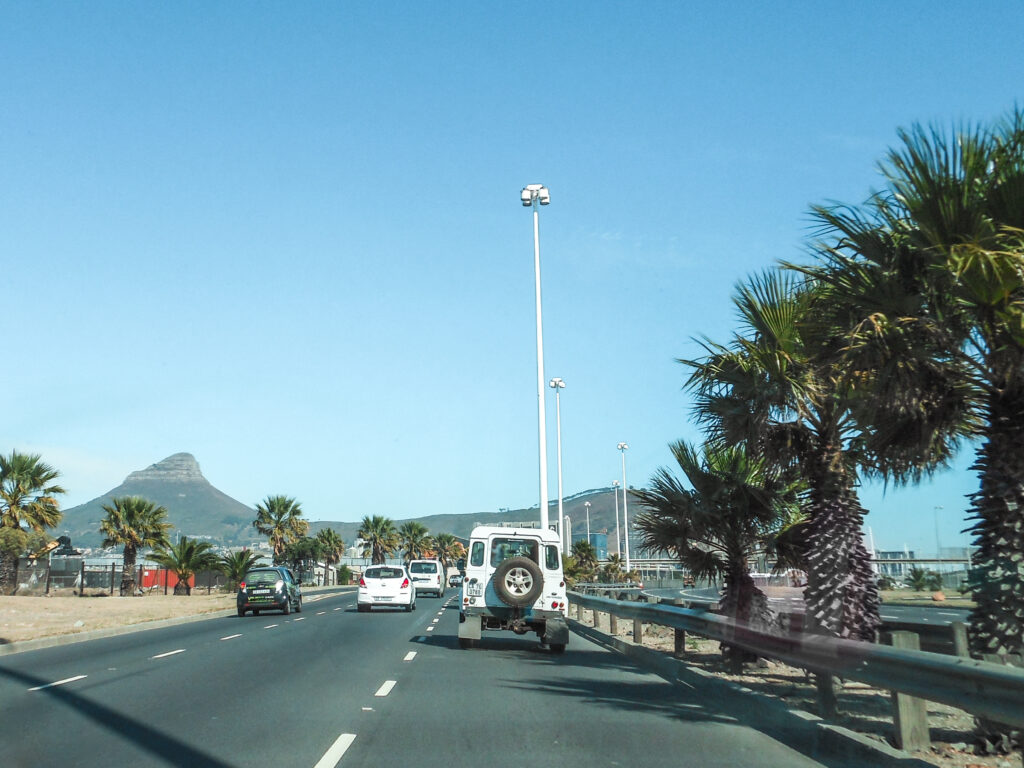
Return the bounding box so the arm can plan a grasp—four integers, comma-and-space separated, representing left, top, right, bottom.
459, 525, 569, 653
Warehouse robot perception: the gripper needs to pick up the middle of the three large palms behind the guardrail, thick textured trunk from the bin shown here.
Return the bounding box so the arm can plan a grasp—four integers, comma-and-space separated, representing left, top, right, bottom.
681, 271, 881, 640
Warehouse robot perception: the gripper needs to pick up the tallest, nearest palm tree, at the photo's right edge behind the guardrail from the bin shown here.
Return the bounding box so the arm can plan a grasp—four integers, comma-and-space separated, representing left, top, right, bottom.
809, 110, 1024, 667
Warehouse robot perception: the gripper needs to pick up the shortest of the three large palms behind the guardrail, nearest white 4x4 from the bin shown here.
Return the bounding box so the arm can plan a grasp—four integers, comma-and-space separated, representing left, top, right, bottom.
633, 440, 798, 665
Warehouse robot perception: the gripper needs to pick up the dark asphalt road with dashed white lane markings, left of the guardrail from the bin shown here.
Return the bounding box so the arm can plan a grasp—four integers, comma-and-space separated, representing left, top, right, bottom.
0, 592, 856, 768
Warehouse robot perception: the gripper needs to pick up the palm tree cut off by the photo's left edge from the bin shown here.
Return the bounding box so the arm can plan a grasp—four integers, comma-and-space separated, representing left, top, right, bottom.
0, 451, 65, 595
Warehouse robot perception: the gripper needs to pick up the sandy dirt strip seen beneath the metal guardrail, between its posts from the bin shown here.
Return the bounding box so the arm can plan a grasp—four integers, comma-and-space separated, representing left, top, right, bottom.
581, 609, 1024, 768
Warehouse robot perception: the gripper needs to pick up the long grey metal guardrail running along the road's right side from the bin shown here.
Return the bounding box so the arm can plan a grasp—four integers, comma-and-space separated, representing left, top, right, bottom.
569, 592, 1024, 727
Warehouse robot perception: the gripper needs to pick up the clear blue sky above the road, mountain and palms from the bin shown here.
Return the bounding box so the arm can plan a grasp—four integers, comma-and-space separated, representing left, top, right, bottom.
0, 0, 1024, 552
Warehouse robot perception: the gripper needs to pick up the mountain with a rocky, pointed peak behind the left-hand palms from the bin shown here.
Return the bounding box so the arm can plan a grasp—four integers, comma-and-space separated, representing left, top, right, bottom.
54, 454, 259, 547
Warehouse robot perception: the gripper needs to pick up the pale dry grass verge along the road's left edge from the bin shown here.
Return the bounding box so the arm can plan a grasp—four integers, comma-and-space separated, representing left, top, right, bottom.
0, 590, 234, 644
